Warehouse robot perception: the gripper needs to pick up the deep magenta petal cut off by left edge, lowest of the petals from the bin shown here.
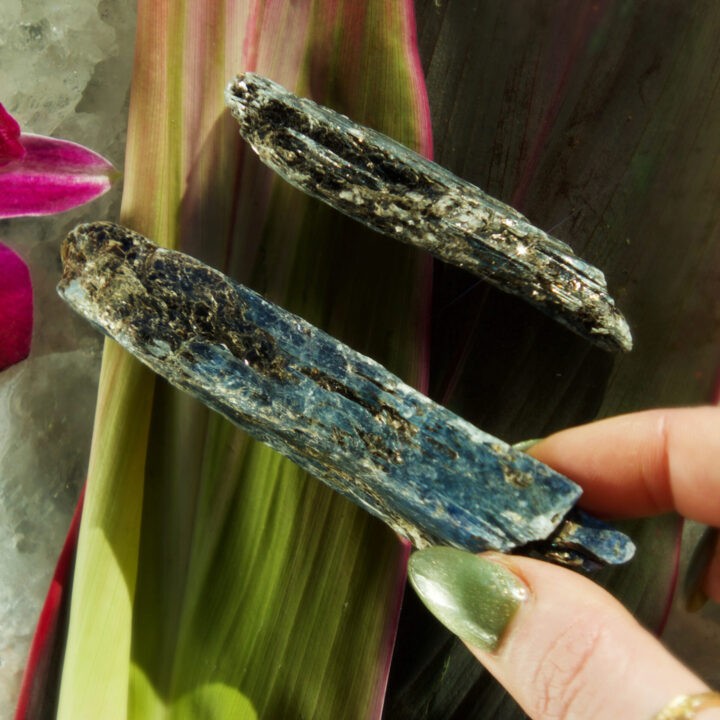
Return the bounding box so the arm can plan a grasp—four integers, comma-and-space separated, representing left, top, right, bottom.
0, 244, 32, 370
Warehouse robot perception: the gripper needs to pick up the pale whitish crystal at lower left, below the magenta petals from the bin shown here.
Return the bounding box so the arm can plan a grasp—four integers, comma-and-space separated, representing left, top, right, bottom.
0, 349, 100, 717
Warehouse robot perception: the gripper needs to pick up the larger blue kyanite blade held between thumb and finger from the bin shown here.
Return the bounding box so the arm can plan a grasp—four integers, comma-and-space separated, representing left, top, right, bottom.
58, 223, 633, 567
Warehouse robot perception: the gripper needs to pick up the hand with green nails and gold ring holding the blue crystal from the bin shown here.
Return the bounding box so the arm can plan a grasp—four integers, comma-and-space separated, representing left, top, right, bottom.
409, 407, 720, 720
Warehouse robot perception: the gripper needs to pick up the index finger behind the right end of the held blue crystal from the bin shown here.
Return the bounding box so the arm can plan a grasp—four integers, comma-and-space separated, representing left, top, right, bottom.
528, 407, 720, 526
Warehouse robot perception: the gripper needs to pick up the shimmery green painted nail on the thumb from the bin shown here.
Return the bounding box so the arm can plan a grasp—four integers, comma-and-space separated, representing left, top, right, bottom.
408, 547, 529, 651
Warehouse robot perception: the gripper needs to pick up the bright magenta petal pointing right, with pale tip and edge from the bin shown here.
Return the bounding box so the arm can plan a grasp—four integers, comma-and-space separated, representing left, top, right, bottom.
0, 134, 117, 218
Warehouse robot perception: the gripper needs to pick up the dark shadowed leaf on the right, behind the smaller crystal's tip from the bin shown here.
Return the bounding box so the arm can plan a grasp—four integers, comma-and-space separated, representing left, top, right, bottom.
387, 0, 720, 720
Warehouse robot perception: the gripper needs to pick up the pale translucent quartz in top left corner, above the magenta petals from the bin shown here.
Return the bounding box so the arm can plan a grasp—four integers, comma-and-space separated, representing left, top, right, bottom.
0, 0, 134, 142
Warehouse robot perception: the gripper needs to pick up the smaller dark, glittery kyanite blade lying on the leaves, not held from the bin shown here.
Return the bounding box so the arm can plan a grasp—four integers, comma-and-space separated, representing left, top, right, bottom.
225, 73, 632, 350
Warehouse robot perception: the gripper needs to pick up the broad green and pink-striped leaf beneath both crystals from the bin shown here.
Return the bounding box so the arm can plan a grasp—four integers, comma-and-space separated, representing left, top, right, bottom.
60, 0, 429, 718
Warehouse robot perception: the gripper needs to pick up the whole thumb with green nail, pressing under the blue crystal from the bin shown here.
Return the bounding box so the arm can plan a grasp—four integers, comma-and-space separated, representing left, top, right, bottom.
408, 547, 720, 720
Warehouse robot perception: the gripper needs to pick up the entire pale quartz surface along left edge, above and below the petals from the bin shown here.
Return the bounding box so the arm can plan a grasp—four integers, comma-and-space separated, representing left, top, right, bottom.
0, 0, 135, 708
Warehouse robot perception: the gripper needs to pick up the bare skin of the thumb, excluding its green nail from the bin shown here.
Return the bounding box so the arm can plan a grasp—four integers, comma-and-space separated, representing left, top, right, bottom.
462, 555, 706, 720
